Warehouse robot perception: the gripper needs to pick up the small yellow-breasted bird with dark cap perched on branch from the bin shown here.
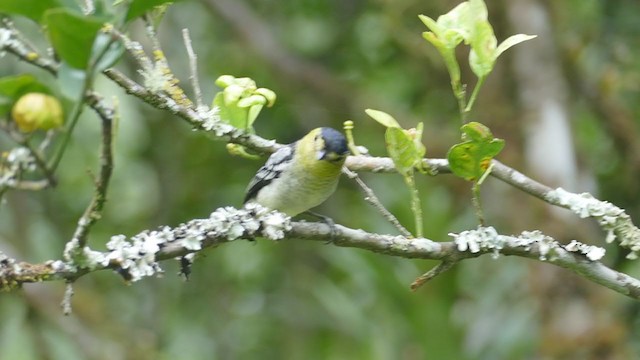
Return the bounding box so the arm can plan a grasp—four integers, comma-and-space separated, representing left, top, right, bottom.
244, 127, 349, 217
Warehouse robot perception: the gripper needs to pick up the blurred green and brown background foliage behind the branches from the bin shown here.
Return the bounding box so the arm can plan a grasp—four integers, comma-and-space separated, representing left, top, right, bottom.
0, 0, 640, 359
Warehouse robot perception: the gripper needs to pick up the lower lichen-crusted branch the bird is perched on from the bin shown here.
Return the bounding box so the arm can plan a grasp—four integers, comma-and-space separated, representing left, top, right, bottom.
0, 204, 640, 300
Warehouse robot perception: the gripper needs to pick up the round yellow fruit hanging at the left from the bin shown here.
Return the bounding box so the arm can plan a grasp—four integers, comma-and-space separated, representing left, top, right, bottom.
11, 93, 64, 132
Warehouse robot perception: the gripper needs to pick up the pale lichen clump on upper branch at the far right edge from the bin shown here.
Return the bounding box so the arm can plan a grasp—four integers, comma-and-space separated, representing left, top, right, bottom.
547, 188, 640, 259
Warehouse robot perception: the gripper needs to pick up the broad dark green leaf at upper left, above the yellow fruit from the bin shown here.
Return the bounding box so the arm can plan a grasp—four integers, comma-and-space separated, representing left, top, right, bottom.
44, 9, 102, 69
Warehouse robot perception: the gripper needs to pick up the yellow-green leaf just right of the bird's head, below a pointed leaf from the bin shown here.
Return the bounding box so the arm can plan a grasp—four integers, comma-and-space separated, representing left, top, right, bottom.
385, 127, 424, 176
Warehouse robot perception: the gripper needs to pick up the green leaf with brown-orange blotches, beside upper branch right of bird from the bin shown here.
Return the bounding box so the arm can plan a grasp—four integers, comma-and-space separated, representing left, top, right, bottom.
447, 122, 504, 181
